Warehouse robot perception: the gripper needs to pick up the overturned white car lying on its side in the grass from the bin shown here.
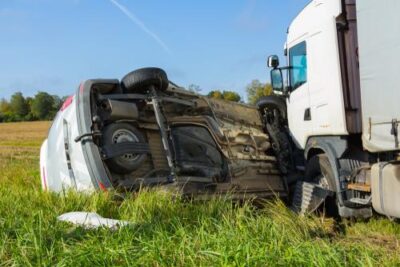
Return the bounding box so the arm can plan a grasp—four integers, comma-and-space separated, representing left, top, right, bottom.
41, 68, 287, 198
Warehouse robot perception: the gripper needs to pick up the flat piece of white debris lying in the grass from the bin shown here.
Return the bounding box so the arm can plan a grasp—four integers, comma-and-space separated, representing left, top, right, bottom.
57, 212, 130, 230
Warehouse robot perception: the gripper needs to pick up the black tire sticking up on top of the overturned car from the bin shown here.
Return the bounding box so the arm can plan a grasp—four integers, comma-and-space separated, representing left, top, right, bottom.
121, 68, 169, 93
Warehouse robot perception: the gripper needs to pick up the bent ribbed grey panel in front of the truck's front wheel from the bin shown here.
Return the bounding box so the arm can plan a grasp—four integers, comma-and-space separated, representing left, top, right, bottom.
291, 182, 334, 215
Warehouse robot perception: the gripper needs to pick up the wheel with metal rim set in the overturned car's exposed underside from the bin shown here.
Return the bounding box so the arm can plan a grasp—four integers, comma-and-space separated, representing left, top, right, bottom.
103, 123, 147, 174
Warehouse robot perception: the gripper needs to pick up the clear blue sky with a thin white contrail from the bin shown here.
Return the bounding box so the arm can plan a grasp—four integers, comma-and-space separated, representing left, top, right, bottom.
0, 0, 309, 98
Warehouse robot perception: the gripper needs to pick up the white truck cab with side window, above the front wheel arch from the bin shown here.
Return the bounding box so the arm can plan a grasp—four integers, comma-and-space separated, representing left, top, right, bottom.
272, 1, 361, 149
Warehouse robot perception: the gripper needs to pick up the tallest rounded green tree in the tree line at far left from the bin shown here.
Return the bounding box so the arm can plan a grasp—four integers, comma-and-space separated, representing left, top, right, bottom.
31, 92, 56, 120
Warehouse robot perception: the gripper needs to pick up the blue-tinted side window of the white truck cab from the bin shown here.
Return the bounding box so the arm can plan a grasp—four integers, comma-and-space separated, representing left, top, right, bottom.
289, 42, 307, 91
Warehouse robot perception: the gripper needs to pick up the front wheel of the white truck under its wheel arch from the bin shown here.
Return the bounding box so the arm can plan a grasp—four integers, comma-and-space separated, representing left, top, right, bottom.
305, 154, 339, 217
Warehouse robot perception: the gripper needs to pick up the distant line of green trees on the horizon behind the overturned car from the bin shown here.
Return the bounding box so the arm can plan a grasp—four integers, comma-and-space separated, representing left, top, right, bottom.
0, 80, 272, 122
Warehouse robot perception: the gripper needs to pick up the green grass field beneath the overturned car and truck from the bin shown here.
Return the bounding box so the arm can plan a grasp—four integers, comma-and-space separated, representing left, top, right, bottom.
0, 122, 400, 266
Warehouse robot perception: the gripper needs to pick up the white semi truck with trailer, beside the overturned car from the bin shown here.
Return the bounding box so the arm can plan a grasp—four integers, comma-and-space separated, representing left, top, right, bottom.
266, 0, 400, 218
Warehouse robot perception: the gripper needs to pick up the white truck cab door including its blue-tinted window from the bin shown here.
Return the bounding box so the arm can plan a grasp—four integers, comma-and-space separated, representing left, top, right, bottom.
287, 41, 312, 148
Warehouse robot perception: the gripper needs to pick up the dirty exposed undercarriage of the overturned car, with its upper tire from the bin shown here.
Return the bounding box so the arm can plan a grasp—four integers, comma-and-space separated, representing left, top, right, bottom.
82, 68, 288, 198
